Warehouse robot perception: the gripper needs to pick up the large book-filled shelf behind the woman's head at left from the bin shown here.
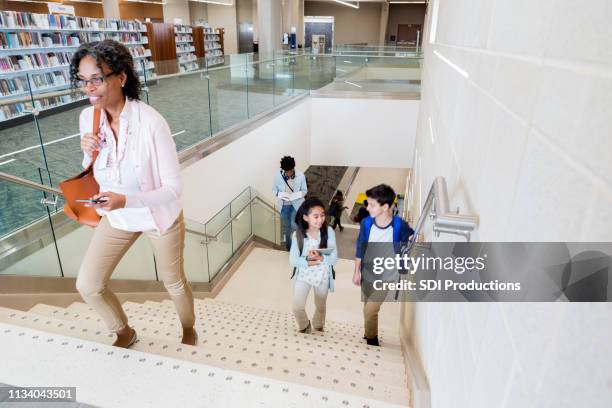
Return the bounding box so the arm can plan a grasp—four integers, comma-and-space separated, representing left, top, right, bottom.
0, 11, 155, 125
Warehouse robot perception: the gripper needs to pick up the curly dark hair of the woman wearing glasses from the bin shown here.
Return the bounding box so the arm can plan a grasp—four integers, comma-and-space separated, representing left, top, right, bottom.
70, 40, 141, 100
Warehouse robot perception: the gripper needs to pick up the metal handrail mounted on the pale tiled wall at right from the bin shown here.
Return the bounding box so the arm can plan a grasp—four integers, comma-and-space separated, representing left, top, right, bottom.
406, 177, 478, 253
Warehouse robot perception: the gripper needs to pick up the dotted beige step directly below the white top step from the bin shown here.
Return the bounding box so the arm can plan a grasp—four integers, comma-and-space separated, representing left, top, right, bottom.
20, 308, 409, 404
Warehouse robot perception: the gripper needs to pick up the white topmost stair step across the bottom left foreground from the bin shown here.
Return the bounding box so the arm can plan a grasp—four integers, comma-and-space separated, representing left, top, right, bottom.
0, 322, 406, 408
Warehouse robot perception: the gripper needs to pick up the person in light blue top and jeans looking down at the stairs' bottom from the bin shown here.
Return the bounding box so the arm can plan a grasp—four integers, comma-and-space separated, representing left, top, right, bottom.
272, 156, 308, 251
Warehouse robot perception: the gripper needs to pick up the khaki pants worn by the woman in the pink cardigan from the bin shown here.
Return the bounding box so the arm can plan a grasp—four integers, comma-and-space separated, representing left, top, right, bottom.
76, 214, 195, 332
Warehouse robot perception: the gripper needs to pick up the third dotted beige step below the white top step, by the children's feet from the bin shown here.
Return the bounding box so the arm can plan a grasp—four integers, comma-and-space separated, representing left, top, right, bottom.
119, 302, 402, 361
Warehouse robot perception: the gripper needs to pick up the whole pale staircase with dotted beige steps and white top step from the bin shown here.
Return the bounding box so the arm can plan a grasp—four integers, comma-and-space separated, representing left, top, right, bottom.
0, 299, 410, 408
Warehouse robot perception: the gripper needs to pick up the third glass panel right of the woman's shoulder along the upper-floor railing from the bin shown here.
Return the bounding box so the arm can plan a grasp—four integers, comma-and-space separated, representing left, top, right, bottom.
245, 54, 274, 117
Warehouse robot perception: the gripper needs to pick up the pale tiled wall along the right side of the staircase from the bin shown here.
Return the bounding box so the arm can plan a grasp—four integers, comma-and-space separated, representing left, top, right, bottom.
412, 0, 612, 407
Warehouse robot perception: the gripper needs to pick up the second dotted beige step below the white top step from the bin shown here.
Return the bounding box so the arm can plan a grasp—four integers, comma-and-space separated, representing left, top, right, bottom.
30, 304, 406, 387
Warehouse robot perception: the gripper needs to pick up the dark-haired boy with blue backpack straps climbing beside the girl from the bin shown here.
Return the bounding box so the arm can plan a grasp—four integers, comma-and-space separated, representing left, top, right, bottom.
353, 184, 414, 346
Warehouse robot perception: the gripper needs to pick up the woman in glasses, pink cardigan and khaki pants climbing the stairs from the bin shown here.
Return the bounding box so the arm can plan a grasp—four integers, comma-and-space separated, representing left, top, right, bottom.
70, 40, 197, 348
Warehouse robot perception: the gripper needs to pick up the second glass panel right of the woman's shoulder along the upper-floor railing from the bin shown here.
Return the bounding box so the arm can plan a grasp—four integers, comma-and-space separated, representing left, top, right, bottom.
208, 64, 249, 134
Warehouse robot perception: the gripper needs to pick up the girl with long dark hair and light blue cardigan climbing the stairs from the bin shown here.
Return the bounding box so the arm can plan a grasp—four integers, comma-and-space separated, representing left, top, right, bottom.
289, 198, 338, 333
